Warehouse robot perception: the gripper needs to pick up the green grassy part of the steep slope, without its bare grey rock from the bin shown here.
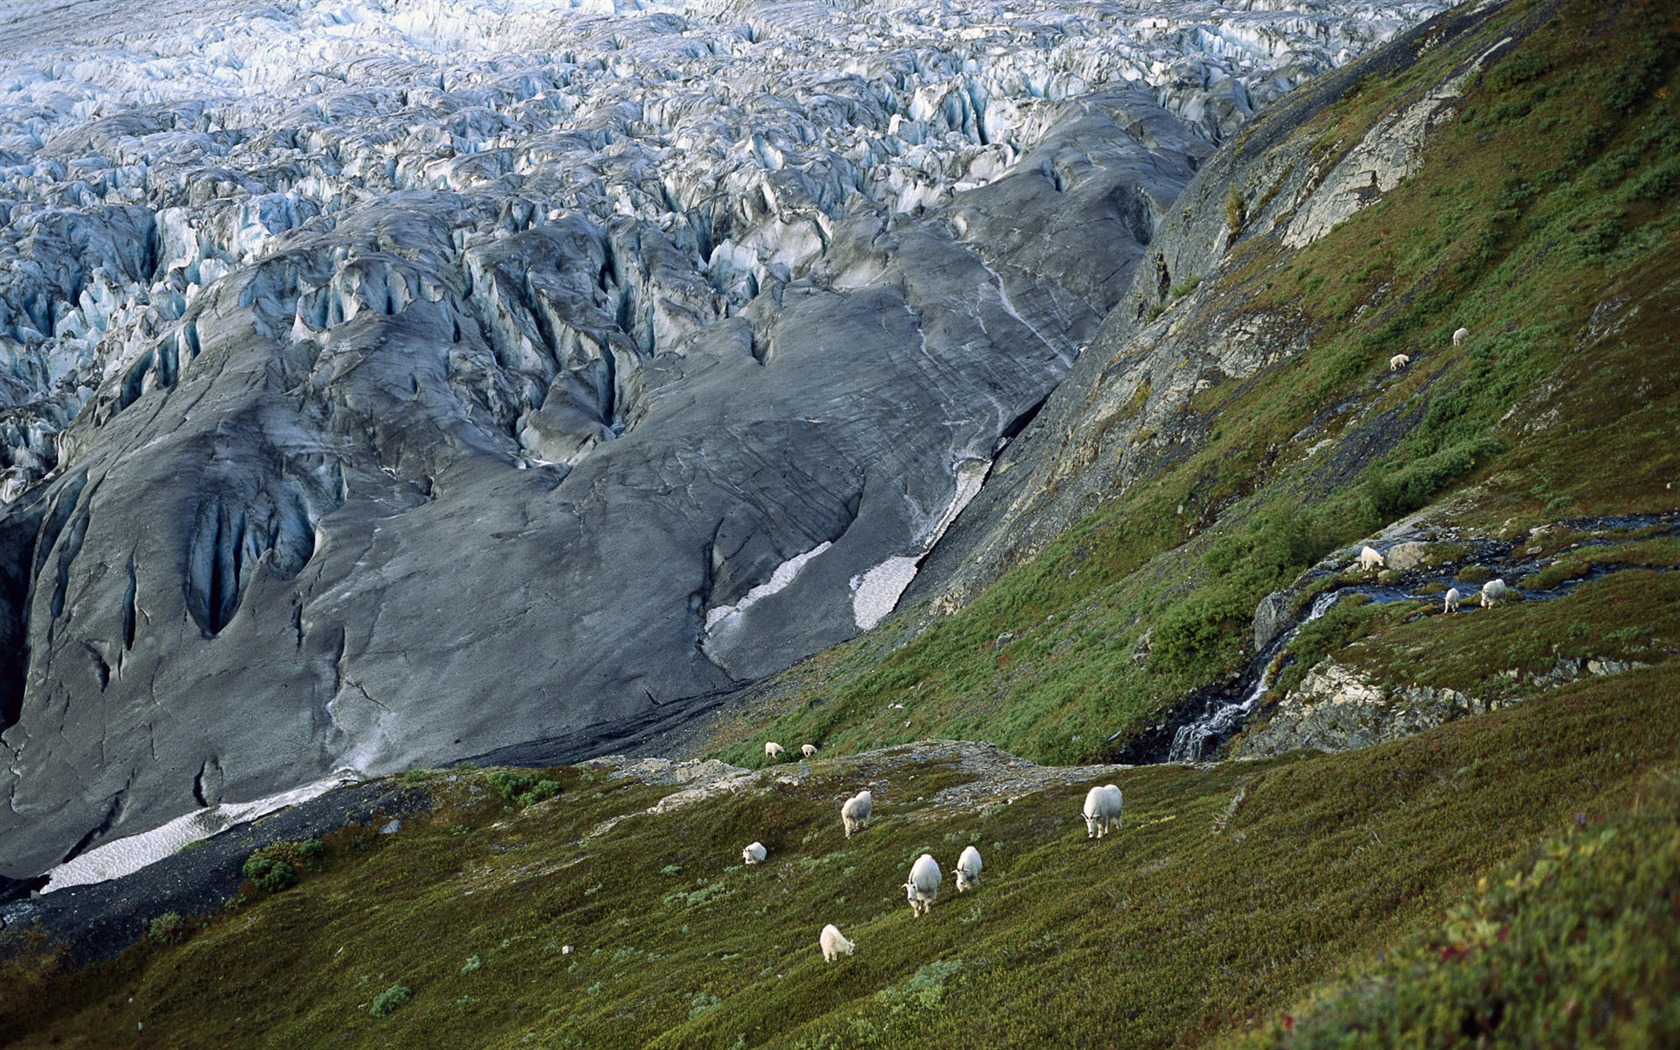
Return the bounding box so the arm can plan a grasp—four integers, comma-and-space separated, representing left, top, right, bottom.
688, 0, 1680, 761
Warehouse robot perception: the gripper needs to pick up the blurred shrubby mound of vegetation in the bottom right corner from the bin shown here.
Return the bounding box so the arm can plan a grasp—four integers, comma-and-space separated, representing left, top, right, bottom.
1243, 773, 1680, 1048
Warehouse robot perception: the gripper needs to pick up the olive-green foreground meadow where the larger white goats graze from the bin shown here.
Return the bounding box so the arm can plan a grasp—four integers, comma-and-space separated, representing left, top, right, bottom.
0, 669, 1680, 1047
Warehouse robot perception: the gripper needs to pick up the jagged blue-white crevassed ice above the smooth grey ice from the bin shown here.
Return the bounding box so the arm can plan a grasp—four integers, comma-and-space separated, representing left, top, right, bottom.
0, 0, 1446, 501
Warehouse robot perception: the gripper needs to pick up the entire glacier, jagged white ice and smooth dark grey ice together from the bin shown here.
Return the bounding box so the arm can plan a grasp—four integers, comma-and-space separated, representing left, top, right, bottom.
0, 0, 1445, 875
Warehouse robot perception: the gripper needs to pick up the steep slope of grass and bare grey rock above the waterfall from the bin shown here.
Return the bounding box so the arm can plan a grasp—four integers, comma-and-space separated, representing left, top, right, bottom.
688, 3, 1680, 761
